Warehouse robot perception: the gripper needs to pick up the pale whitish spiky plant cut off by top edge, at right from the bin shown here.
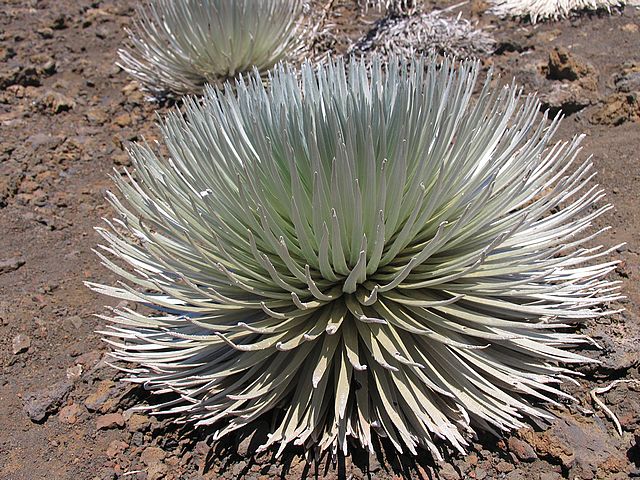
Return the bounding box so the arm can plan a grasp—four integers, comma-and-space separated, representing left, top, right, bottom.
489, 0, 626, 23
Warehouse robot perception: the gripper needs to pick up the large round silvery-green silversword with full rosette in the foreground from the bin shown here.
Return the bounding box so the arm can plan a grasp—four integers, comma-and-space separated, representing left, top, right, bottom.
89, 55, 618, 457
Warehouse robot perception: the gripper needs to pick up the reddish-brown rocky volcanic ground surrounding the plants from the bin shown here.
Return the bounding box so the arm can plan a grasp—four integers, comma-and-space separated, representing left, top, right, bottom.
0, 0, 640, 480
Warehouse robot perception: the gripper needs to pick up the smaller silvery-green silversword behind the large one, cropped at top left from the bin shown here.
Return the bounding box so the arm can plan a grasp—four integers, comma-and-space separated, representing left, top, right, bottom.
118, 0, 305, 96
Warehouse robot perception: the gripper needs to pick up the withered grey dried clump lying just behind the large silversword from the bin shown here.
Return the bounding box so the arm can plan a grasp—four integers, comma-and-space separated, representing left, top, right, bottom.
350, 11, 495, 58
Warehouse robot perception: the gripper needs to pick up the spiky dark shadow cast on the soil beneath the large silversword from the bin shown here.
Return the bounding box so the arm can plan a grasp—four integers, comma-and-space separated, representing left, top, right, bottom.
117, 386, 455, 480
